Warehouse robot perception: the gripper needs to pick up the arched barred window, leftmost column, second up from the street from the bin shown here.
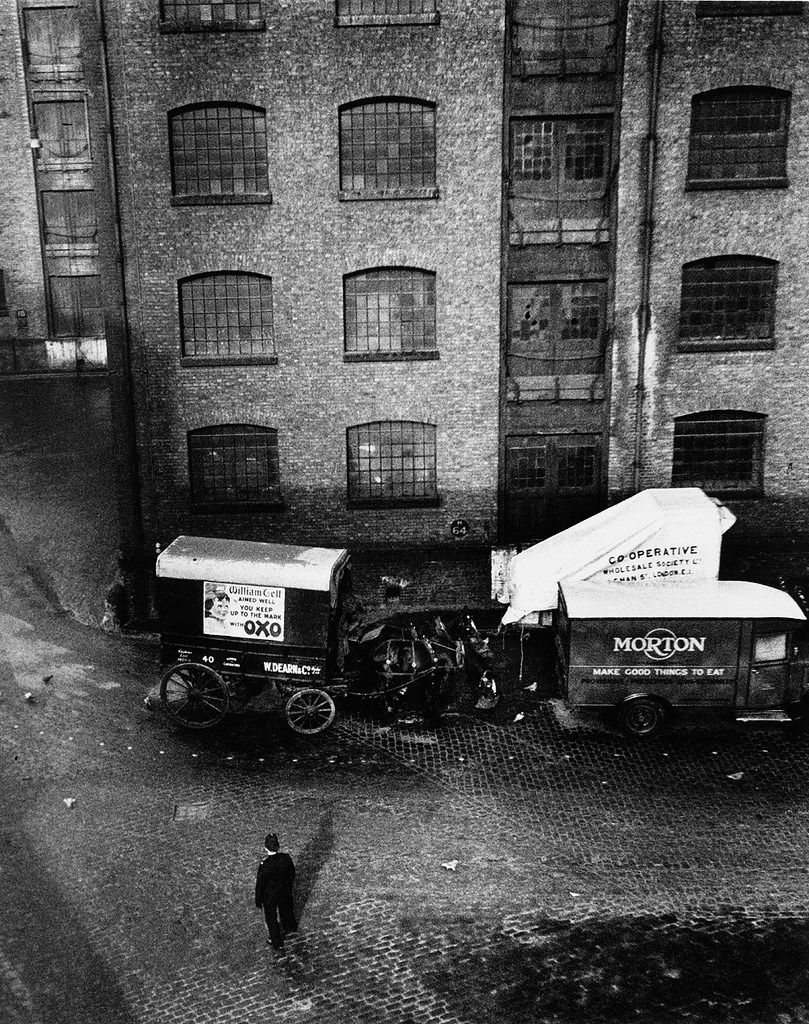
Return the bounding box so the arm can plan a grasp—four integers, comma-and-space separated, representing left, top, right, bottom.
178, 271, 275, 359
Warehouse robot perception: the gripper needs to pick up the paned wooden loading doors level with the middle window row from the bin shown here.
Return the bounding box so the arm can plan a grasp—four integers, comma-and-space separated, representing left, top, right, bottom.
508, 281, 606, 377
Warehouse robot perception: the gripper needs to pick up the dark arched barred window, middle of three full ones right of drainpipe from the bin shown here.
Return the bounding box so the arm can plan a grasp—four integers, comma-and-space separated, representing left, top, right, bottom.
680, 256, 778, 347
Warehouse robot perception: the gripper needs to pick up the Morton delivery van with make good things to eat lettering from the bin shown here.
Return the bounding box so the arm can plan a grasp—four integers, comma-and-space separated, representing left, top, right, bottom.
554, 580, 809, 736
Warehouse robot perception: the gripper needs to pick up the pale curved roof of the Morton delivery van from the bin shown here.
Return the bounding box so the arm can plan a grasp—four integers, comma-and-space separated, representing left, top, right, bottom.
559, 580, 806, 622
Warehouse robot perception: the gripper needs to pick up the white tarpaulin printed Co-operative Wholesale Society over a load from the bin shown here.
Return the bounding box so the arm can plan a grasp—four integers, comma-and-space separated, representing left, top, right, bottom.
501, 487, 736, 625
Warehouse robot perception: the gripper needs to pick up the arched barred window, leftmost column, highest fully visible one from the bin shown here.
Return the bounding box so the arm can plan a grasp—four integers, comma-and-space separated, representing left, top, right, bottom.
169, 103, 269, 203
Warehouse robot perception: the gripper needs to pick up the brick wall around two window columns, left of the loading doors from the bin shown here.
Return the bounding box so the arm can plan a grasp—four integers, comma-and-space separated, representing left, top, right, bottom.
107, 0, 503, 593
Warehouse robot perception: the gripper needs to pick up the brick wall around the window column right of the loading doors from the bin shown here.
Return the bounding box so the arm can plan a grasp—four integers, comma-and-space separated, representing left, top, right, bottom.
610, 2, 809, 537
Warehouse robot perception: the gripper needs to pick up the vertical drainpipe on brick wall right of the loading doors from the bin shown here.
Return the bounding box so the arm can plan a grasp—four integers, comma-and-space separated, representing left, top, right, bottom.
632, 0, 665, 493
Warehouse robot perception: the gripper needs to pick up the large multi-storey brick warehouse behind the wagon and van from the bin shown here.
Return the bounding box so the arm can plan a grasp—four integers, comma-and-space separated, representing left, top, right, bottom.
0, 0, 809, 603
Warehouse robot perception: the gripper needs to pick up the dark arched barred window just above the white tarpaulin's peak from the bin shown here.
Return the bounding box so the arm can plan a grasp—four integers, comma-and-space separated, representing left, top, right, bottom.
672, 410, 765, 495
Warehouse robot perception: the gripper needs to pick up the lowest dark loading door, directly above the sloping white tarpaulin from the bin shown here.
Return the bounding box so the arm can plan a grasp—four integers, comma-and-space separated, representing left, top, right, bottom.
505, 434, 603, 541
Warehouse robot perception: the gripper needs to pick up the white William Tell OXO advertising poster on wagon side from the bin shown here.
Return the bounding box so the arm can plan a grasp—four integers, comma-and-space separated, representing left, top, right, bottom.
203, 581, 285, 643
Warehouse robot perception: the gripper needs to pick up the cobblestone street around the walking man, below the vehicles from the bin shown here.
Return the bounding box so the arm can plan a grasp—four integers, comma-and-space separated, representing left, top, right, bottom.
0, 545, 809, 1024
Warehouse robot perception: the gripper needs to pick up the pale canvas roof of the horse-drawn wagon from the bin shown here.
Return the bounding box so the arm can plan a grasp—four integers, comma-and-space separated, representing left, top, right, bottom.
157, 537, 348, 591
